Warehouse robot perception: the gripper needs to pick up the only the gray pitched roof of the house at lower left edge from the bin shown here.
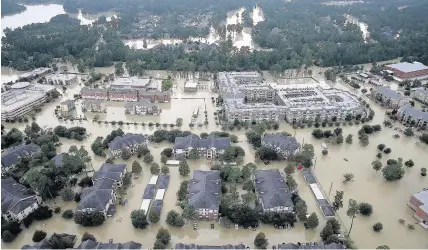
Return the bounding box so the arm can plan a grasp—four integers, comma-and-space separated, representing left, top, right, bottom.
1, 177, 37, 214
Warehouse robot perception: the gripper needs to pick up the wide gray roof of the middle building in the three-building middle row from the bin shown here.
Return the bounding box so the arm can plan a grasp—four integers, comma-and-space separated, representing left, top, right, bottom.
174, 134, 230, 149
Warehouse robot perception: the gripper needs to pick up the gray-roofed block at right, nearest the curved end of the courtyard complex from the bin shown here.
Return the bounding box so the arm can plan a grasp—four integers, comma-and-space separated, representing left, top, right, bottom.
371, 86, 409, 109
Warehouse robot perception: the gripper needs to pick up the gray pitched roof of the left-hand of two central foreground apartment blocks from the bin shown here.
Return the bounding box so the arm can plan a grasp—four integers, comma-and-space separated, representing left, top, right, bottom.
189, 170, 221, 210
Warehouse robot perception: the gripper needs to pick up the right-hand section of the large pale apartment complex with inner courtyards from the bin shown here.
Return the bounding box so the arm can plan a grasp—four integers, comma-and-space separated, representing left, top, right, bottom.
276, 87, 366, 124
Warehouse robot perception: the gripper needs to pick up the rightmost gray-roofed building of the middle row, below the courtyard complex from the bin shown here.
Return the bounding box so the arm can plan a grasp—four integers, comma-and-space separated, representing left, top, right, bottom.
261, 133, 300, 159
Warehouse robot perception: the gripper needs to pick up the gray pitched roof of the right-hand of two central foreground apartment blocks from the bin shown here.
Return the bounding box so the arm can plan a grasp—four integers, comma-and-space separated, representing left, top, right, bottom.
255, 169, 294, 209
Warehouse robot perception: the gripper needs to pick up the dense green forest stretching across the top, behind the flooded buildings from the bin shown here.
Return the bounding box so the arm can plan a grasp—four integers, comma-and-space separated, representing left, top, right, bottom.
2, 0, 428, 73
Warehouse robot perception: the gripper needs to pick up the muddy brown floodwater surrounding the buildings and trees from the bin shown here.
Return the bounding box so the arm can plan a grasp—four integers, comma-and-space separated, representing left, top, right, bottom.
2, 68, 428, 248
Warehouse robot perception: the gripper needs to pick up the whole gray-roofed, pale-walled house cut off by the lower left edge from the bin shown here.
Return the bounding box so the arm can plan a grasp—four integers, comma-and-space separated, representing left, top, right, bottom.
1, 177, 41, 222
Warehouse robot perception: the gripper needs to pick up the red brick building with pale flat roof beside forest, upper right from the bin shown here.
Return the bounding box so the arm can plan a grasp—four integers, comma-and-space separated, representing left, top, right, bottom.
385, 62, 428, 79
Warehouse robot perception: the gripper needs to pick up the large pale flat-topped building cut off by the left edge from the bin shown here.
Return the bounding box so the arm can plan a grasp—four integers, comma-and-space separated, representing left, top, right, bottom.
1, 82, 55, 121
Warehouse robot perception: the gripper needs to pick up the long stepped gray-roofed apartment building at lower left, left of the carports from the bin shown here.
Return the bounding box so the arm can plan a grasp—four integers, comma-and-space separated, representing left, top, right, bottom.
75, 163, 126, 216
